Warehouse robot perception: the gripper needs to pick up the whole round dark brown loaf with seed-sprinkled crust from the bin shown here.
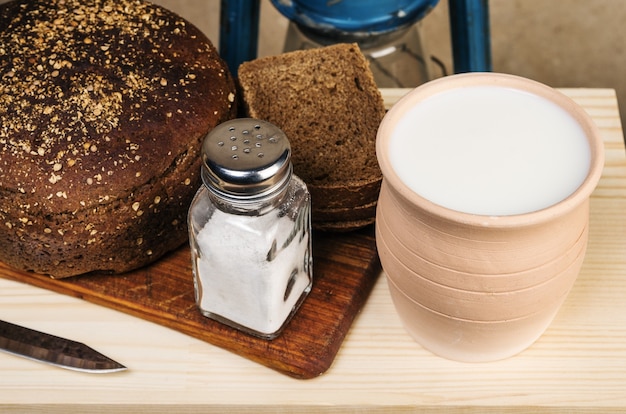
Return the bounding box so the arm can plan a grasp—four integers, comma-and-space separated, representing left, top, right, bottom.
0, 0, 236, 278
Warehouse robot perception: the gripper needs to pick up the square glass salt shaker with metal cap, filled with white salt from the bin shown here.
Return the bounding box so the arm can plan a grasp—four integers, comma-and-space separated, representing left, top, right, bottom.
188, 118, 313, 339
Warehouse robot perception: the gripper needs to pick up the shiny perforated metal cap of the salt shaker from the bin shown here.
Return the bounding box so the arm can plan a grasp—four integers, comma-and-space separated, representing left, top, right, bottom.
202, 118, 292, 198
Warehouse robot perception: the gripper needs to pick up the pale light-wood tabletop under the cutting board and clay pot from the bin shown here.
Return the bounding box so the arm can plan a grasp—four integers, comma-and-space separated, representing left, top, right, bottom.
0, 89, 626, 413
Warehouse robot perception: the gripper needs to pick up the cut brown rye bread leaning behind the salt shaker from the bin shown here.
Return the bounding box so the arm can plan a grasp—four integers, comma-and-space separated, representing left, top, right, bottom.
238, 44, 385, 227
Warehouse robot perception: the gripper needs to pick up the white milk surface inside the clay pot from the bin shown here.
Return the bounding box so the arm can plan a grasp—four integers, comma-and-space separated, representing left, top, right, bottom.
389, 86, 591, 216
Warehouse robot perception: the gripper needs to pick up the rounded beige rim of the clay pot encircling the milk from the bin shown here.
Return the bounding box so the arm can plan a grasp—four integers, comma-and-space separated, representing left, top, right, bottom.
376, 72, 604, 228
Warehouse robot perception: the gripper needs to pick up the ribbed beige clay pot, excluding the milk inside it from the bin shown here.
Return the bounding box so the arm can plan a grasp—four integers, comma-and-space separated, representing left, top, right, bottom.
376, 73, 604, 361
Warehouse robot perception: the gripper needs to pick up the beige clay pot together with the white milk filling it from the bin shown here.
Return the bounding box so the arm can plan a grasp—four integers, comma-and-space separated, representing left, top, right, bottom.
376, 73, 604, 361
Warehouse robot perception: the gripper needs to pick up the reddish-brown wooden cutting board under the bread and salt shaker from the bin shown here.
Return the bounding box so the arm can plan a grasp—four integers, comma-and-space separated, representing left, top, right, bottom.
0, 226, 380, 379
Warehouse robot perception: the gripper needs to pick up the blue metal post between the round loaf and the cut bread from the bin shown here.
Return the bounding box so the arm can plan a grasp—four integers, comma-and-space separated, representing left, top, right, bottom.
219, 0, 261, 76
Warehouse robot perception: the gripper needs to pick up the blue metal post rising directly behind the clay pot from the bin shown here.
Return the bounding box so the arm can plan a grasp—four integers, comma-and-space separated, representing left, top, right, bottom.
448, 0, 492, 73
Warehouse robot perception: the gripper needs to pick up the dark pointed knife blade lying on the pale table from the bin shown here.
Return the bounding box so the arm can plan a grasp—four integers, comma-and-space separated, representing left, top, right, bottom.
0, 320, 126, 373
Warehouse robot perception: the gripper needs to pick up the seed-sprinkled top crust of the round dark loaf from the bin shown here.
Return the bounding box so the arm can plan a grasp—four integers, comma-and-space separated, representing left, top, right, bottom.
0, 0, 234, 215
